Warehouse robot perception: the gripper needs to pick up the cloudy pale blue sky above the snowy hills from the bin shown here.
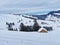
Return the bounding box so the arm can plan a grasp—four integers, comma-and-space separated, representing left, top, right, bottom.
0, 0, 60, 14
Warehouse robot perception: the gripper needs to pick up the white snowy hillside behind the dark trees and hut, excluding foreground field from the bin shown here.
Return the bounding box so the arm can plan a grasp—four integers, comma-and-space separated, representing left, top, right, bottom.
0, 14, 60, 30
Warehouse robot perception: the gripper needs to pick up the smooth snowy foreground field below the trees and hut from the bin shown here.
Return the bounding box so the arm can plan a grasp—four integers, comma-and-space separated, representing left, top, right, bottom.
0, 30, 60, 45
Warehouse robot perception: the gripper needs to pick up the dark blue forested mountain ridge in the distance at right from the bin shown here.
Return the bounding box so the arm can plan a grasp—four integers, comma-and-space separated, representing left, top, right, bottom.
32, 10, 60, 20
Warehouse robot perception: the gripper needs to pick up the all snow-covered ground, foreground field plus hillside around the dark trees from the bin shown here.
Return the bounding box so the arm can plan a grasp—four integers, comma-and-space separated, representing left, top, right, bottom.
0, 14, 60, 45
